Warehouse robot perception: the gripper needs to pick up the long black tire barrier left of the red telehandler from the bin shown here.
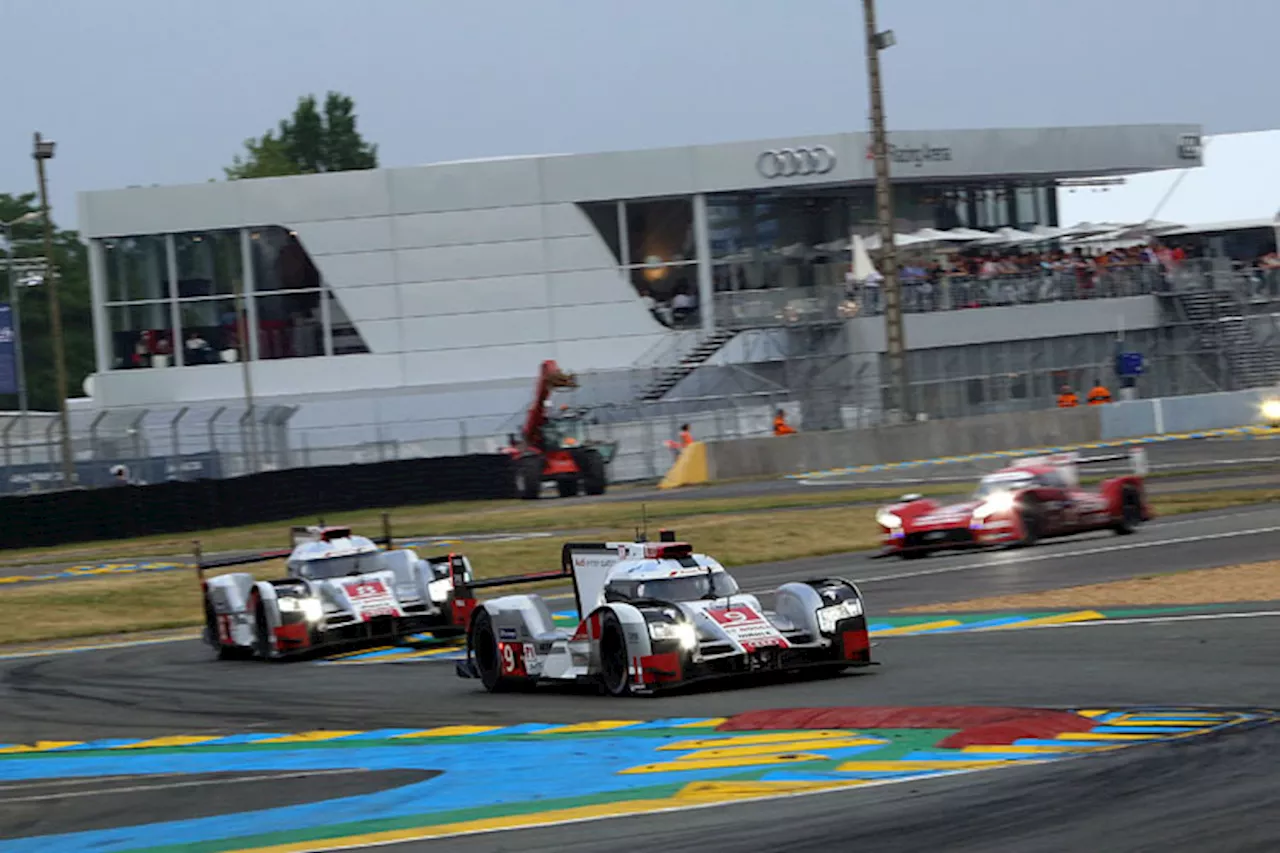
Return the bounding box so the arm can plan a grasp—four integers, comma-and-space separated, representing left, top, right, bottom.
0, 453, 513, 548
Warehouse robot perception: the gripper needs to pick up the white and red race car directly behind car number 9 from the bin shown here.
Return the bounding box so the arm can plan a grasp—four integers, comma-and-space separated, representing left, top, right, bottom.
197, 517, 476, 660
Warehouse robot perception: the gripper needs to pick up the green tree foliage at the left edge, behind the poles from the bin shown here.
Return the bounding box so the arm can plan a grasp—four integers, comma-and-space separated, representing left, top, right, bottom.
0, 192, 95, 411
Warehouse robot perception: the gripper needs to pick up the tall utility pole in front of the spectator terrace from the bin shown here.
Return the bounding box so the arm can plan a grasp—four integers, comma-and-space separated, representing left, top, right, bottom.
863, 0, 911, 420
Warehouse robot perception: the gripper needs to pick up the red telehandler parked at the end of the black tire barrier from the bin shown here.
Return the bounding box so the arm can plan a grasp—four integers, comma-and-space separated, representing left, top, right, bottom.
506, 360, 617, 501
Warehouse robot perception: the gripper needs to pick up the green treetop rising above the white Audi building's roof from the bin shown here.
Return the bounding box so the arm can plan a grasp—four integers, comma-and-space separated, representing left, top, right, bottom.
223, 92, 378, 181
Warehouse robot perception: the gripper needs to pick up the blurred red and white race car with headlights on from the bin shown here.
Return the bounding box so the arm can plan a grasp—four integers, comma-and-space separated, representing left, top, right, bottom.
876, 447, 1152, 560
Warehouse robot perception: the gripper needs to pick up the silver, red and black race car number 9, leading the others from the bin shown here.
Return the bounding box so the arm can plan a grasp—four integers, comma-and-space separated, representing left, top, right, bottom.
457, 532, 873, 697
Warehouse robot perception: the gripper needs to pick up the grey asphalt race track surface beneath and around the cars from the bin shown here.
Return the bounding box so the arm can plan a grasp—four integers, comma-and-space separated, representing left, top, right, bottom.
0, 507, 1280, 853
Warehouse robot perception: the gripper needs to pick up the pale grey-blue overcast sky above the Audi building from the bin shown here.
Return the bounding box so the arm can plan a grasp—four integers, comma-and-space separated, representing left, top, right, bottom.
0, 0, 1280, 225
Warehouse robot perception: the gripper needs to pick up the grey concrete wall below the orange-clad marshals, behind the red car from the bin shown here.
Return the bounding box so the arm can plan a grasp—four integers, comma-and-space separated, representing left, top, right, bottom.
707, 407, 1102, 480
